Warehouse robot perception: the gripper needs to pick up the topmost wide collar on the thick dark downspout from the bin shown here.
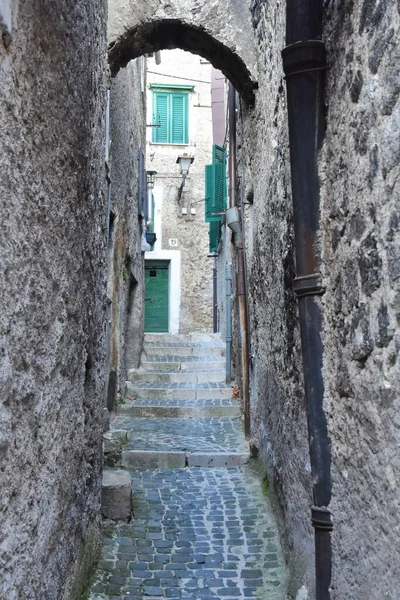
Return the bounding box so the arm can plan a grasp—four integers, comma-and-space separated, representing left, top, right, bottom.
282, 40, 326, 78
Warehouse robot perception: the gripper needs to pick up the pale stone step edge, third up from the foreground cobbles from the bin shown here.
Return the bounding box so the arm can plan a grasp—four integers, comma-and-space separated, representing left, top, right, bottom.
126, 381, 233, 400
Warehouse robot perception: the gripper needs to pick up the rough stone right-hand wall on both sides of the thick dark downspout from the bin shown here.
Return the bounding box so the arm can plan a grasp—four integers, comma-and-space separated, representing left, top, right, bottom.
239, 0, 400, 600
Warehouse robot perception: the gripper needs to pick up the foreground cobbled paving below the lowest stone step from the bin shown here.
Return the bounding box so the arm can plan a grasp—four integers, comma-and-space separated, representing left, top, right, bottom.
89, 466, 287, 600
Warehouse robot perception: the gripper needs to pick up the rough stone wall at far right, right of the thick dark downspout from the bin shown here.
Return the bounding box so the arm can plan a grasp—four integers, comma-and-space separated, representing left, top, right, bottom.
321, 0, 400, 600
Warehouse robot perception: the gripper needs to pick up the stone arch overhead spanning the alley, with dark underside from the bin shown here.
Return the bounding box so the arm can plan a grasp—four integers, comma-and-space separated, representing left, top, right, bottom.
108, 0, 257, 104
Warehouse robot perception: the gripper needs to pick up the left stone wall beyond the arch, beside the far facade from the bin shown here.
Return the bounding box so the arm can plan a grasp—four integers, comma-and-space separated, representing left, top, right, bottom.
108, 58, 146, 394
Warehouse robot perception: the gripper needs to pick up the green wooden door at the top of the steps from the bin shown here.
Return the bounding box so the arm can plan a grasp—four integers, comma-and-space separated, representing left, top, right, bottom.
144, 262, 168, 333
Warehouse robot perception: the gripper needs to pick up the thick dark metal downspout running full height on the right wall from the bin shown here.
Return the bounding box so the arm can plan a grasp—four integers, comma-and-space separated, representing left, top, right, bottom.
282, 0, 333, 600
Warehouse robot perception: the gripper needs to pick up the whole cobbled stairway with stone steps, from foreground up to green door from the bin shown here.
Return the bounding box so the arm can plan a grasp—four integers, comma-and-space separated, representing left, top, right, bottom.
89, 334, 286, 600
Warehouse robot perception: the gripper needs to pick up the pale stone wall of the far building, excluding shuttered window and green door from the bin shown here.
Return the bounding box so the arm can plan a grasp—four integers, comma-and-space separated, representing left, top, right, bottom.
146, 50, 213, 333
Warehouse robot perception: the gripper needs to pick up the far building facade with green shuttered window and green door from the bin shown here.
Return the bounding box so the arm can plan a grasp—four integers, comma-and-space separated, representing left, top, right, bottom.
145, 50, 213, 333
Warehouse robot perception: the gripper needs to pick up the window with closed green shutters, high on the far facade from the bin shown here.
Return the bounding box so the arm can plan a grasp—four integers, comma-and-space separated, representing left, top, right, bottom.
151, 85, 194, 144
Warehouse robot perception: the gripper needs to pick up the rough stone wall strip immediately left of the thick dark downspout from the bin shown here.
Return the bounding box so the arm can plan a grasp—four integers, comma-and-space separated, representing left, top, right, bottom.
238, 0, 313, 597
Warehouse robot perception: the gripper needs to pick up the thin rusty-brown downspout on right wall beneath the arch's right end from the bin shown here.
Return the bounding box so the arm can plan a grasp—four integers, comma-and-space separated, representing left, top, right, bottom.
228, 83, 250, 437
